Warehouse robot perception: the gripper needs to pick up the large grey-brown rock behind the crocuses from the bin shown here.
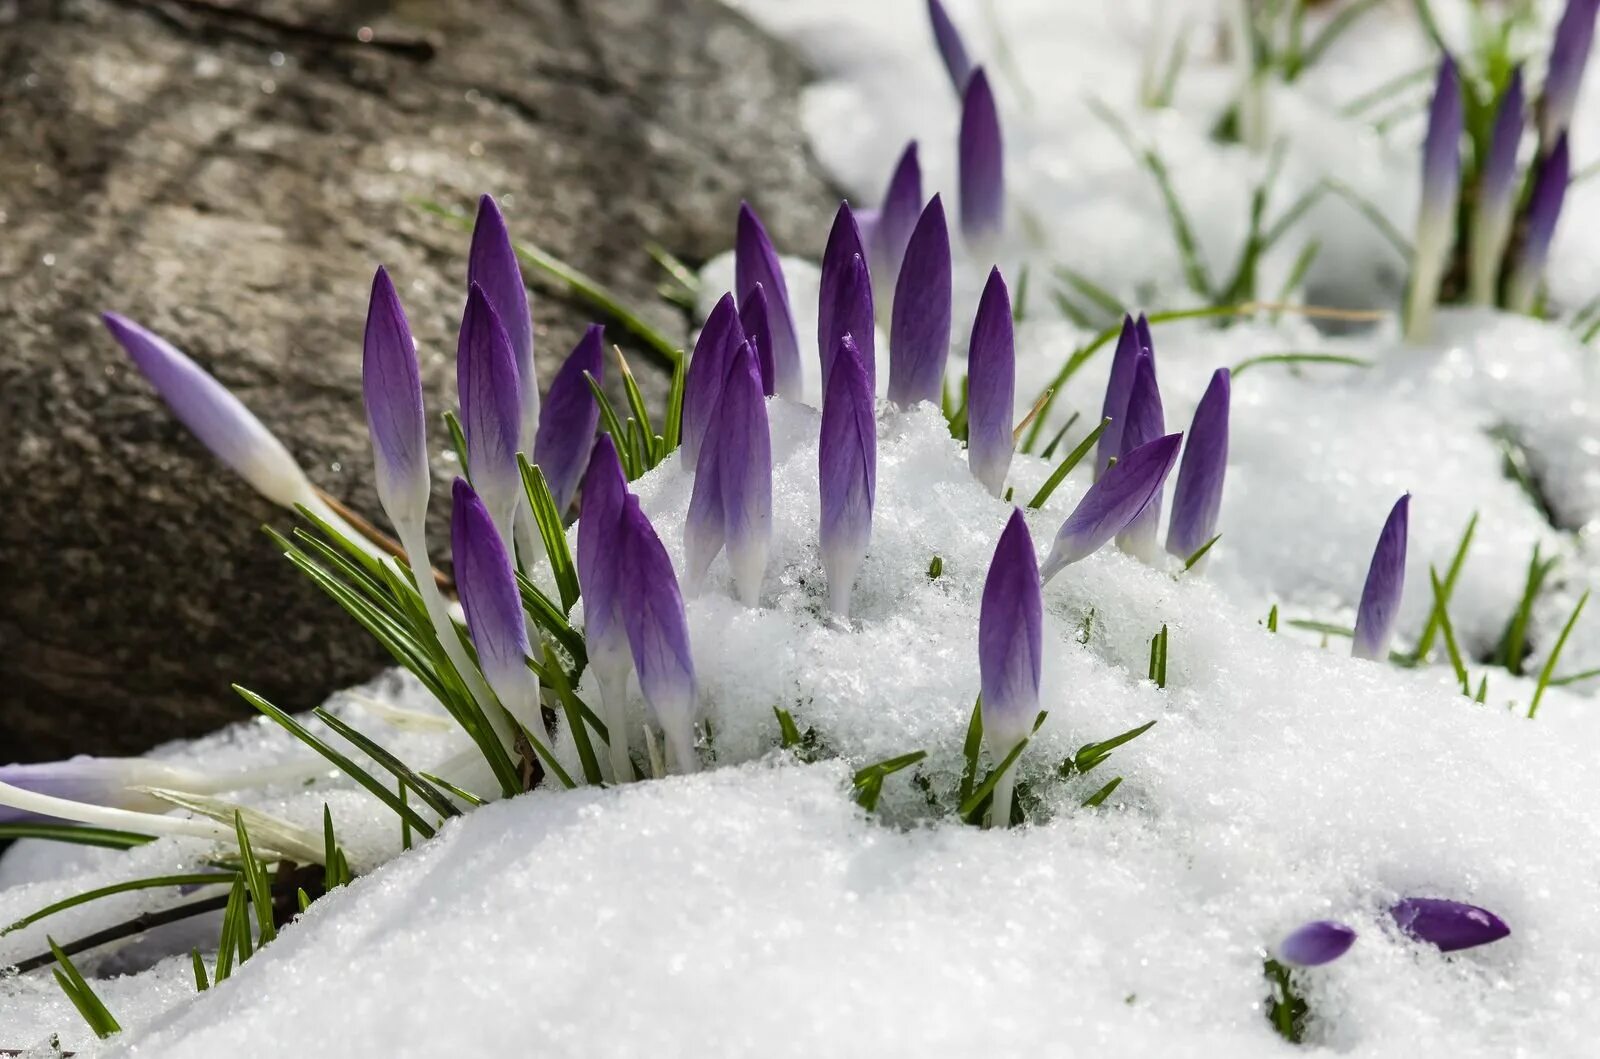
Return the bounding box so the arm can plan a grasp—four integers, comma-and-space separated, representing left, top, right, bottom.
0, 0, 829, 761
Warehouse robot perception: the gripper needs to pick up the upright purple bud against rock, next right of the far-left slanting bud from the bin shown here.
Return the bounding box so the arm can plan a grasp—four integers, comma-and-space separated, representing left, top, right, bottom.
362, 269, 429, 526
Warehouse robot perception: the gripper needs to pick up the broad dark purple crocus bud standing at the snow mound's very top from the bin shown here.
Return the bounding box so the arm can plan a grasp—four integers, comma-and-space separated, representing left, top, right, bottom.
889, 195, 950, 408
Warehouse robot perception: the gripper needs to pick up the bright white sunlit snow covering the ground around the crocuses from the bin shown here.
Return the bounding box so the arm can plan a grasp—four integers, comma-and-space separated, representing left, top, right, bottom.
9, 0, 1600, 1059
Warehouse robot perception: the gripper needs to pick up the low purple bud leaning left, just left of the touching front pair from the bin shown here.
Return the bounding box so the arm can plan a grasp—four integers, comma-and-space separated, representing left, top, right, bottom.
450, 478, 542, 739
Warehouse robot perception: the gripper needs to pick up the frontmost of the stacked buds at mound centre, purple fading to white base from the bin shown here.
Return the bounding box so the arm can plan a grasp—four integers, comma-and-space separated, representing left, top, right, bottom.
818, 334, 878, 617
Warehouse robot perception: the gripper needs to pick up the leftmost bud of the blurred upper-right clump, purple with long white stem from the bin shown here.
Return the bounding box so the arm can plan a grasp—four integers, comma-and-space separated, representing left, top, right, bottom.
1405, 54, 1462, 341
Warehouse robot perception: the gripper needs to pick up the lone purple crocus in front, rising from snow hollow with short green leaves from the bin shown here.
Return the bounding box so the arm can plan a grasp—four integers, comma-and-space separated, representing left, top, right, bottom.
978, 509, 1045, 827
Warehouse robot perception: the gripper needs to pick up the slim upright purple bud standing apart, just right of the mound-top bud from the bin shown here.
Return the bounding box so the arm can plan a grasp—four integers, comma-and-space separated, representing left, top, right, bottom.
966, 269, 1016, 496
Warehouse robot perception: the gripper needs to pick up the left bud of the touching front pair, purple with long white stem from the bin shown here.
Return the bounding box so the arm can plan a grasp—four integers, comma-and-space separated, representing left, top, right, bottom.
578, 434, 634, 782
